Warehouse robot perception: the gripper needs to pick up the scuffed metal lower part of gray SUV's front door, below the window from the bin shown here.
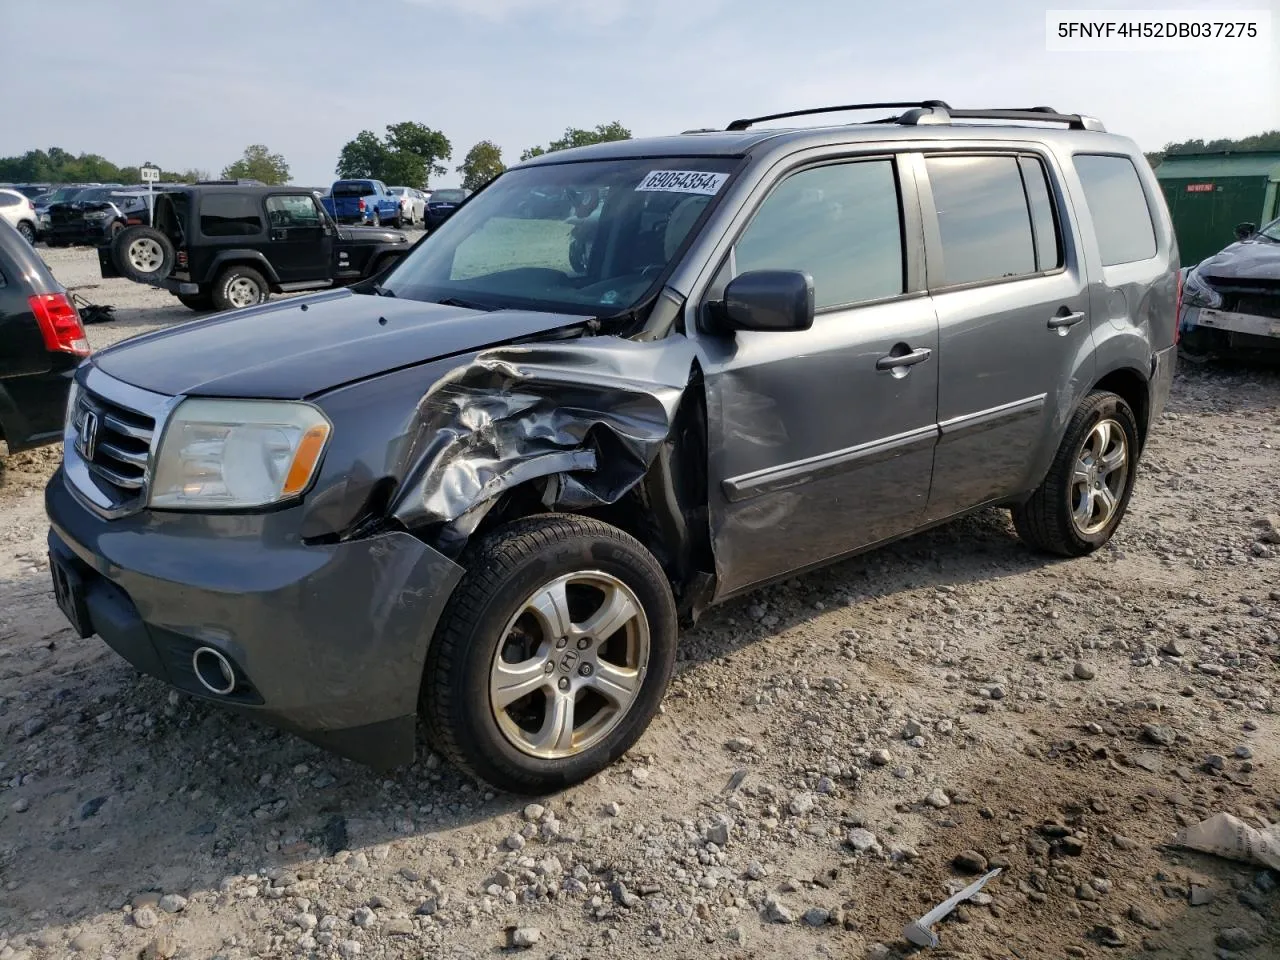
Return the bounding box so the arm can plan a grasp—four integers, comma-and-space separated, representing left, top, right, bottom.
707, 297, 938, 593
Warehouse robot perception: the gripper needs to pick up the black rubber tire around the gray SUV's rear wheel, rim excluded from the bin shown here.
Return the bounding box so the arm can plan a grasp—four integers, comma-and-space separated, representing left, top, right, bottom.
1012, 390, 1142, 557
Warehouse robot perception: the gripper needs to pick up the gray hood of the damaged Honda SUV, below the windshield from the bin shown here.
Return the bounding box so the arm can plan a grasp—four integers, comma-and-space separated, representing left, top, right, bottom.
93, 291, 584, 399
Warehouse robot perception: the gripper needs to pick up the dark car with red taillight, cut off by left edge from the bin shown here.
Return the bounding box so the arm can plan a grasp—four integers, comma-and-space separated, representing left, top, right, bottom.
0, 220, 88, 453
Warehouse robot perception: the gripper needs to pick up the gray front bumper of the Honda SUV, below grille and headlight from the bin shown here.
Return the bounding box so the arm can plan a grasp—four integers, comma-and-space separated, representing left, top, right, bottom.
45, 470, 462, 768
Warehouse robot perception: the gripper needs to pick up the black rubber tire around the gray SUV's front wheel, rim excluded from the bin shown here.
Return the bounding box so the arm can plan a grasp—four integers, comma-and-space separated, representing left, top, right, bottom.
421, 513, 677, 794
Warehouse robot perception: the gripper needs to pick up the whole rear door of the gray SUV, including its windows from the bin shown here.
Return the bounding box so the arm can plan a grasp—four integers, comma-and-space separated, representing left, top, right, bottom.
920, 155, 1093, 521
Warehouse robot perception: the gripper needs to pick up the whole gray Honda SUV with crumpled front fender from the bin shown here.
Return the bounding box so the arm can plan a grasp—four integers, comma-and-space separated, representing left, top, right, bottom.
46, 101, 1180, 792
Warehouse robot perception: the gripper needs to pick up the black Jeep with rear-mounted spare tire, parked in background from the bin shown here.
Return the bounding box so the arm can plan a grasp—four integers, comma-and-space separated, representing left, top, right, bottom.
97, 184, 410, 310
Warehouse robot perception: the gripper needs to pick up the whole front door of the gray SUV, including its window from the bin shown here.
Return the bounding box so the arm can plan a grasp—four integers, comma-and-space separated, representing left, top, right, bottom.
699, 157, 938, 596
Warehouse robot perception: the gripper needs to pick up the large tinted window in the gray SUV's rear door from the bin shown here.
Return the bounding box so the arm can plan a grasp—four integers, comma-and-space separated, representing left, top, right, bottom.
924, 156, 1037, 287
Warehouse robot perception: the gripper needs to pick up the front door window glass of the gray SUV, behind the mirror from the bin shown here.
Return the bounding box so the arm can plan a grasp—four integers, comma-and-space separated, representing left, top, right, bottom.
733, 160, 904, 310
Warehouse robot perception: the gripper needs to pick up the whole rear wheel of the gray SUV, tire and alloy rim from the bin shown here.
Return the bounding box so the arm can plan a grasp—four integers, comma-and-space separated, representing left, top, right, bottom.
1012, 390, 1140, 557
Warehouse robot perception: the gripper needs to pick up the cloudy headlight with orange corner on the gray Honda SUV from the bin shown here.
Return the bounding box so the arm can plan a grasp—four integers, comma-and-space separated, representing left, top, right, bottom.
150, 398, 333, 509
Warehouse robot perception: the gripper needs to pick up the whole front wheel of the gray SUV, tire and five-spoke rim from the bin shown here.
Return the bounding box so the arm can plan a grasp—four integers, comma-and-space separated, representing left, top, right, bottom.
422, 515, 676, 794
